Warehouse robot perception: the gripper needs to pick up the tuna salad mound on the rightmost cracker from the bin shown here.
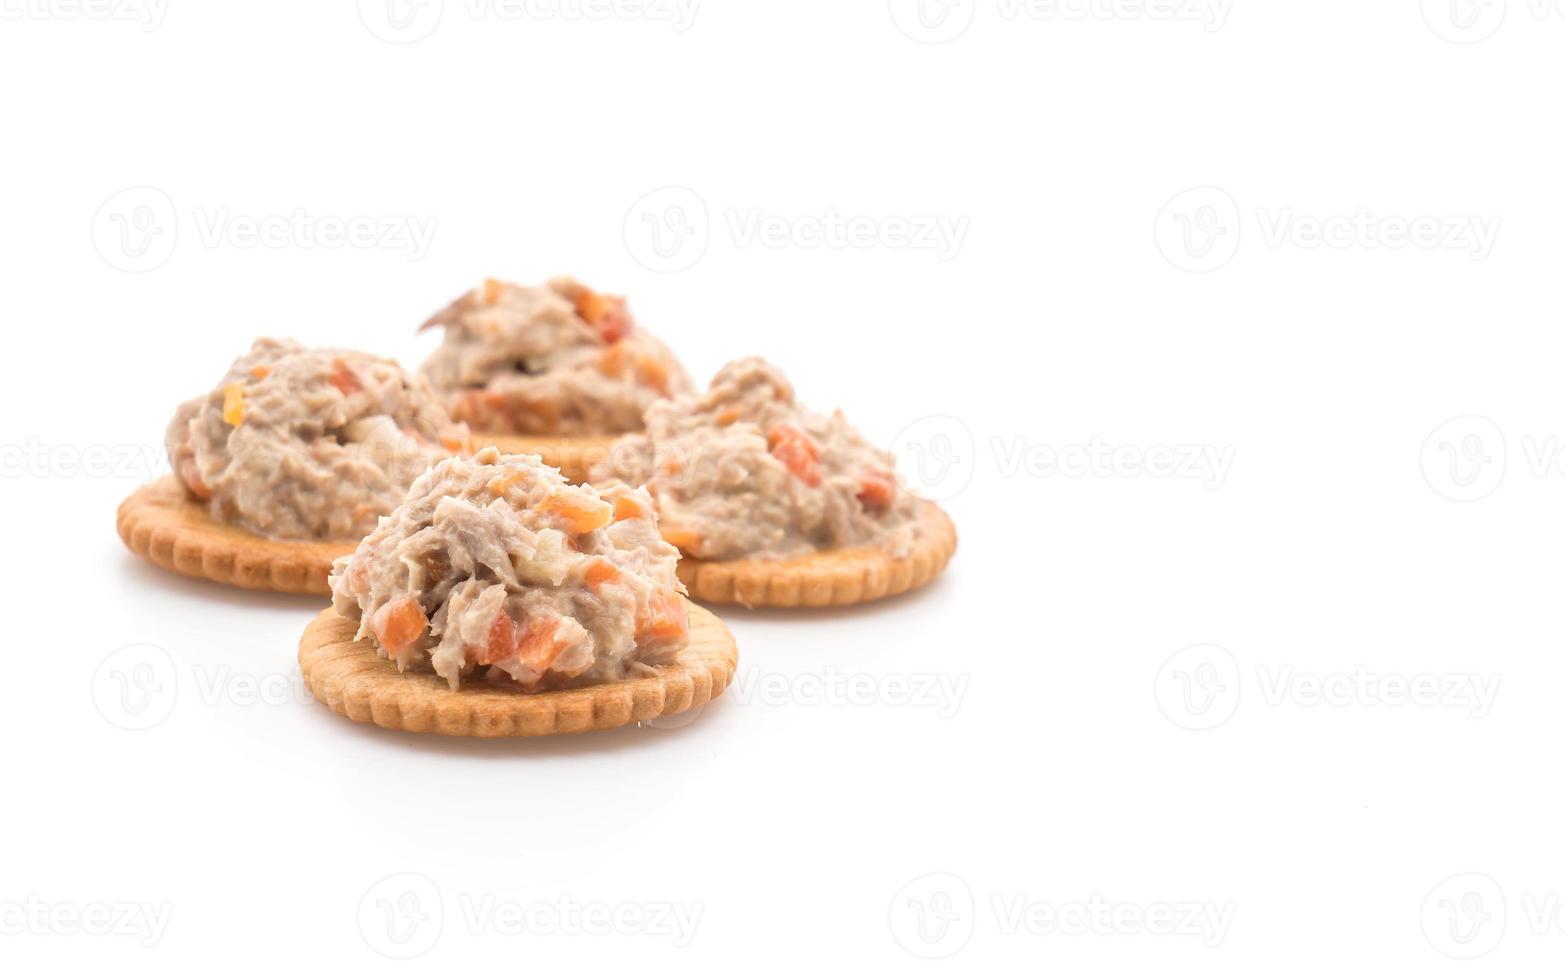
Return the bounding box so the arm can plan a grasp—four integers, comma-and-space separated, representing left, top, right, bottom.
590, 357, 919, 560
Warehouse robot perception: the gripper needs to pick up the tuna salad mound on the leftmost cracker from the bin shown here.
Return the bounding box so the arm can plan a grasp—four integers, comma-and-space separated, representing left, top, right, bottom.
166, 338, 466, 540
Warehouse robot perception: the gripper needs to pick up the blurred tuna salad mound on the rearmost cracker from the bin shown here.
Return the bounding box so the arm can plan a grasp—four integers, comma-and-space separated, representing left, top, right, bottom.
421, 279, 690, 435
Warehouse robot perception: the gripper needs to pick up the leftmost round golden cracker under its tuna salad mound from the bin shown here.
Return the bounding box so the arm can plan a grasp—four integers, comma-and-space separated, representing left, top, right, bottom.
116, 474, 358, 595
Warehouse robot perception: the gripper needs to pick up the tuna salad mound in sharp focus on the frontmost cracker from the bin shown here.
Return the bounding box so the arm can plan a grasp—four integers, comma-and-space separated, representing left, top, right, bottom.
332, 448, 689, 692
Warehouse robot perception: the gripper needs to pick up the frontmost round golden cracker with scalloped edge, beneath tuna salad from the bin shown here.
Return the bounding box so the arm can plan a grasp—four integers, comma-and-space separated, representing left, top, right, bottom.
299, 600, 739, 739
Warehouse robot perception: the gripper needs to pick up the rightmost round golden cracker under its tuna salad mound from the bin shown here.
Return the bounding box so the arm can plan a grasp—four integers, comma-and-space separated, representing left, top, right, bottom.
679, 501, 956, 609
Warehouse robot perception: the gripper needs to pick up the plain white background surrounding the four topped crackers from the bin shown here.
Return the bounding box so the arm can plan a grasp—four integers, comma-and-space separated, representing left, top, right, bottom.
0, 0, 1565, 977
